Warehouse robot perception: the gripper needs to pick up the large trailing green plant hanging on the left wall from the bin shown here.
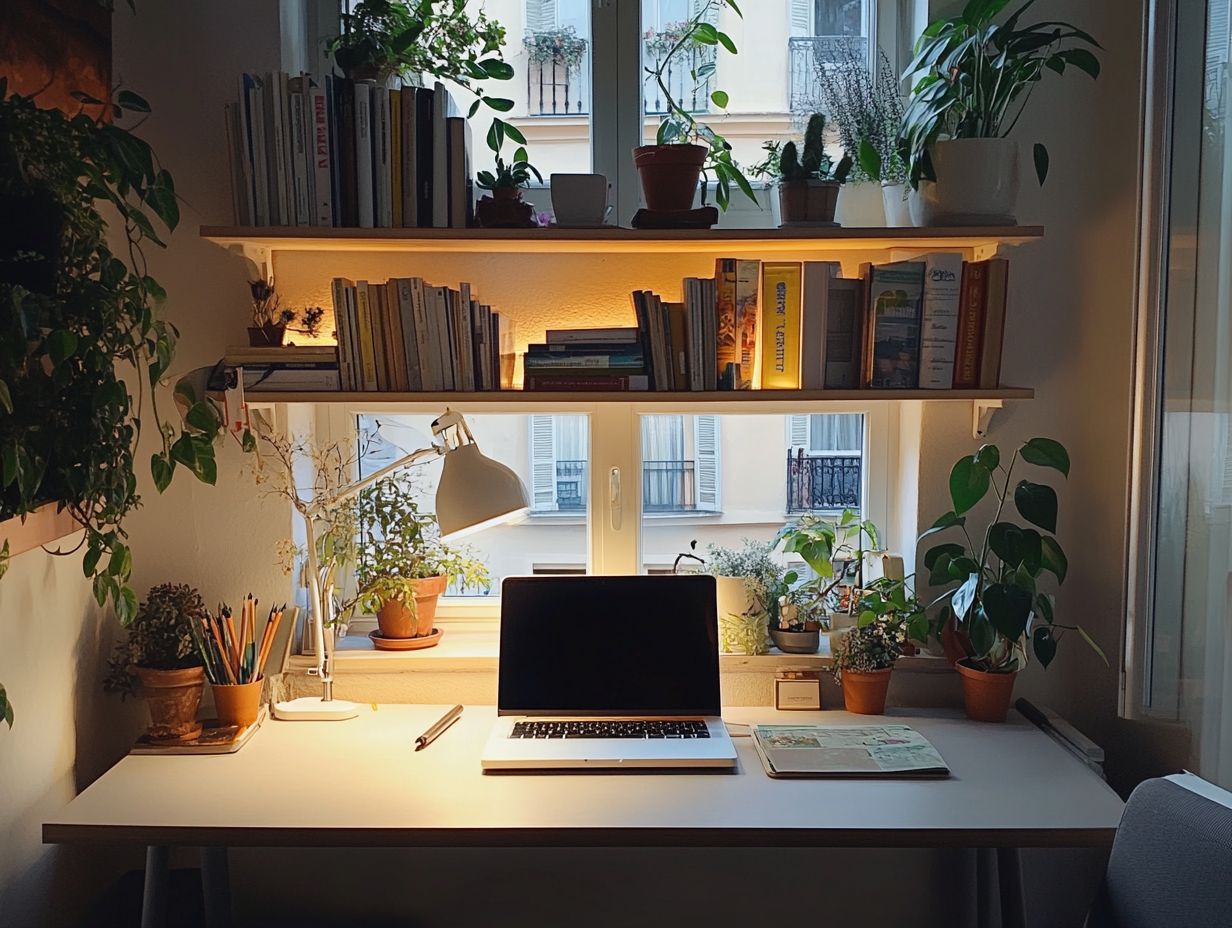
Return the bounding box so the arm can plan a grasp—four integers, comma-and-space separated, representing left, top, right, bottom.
0, 79, 222, 723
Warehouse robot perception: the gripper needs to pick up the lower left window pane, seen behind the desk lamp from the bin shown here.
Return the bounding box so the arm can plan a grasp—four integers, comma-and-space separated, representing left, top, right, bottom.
359, 414, 589, 596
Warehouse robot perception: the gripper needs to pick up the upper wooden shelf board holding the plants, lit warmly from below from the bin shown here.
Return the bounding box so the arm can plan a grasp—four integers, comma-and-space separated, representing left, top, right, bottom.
201, 226, 1044, 258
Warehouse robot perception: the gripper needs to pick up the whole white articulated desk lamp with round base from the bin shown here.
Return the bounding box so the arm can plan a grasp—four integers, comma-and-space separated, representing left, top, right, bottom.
274, 409, 529, 721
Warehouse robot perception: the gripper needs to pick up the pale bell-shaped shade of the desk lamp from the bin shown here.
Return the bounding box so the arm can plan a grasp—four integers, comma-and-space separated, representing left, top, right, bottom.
436, 444, 529, 539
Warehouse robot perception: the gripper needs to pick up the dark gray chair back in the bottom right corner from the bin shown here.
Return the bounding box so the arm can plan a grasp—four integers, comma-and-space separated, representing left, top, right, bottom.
1087, 774, 1232, 928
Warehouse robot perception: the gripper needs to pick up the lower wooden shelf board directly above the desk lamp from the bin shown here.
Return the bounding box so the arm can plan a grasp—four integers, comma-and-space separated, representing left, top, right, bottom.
237, 387, 1035, 405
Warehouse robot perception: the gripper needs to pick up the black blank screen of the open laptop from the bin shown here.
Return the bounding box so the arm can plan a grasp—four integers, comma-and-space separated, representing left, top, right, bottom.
498, 576, 719, 716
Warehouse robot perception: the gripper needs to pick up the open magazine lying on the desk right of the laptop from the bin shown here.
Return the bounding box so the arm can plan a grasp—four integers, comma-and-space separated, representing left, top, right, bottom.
753, 725, 950, 778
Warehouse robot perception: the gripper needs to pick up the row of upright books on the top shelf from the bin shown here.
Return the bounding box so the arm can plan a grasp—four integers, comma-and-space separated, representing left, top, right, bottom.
224, 71, 474, 228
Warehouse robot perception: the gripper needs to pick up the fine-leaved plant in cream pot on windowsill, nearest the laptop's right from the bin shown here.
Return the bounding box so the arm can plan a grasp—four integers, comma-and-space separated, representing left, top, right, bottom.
706, 539, 788, 654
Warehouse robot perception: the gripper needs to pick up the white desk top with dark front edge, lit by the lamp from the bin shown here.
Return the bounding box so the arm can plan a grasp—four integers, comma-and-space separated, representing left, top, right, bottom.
43, 705, 1122, 847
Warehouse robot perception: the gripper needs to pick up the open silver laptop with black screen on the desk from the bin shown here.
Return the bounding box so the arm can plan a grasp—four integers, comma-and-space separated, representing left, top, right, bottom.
482, 576, 736, 771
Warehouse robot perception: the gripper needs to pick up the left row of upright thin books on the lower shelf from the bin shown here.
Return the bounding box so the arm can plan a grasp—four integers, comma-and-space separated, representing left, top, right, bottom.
333, 277, 514, 392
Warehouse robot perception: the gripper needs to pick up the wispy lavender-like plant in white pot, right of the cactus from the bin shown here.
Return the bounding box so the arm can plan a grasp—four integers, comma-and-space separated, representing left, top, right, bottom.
816, 44, 910, 227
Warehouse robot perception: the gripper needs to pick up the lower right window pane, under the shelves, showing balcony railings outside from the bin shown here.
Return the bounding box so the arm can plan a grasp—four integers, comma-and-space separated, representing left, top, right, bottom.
641, 413, 866, 573
